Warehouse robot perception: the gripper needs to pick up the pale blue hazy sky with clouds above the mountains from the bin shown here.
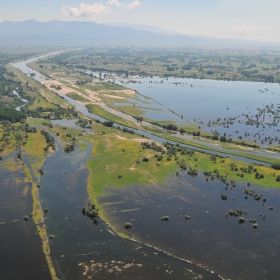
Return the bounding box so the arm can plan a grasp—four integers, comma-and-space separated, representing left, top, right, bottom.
0, 0, 280, 42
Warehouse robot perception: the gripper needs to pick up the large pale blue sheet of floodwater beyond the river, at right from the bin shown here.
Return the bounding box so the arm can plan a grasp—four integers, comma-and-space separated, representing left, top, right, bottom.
93, 72, 280, 146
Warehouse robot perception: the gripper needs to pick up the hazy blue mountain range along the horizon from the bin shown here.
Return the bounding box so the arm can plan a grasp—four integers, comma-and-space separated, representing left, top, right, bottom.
0, 20, 276, 47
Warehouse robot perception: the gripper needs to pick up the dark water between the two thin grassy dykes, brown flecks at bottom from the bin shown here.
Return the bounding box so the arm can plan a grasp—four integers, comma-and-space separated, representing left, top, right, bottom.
40, 137, 219, 280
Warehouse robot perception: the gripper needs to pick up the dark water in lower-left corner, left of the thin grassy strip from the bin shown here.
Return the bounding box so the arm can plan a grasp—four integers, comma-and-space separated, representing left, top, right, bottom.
0, 155, 51, 280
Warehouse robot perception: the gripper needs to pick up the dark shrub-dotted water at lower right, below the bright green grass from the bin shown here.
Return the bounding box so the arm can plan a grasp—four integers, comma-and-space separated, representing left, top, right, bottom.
100, 173, 280, 279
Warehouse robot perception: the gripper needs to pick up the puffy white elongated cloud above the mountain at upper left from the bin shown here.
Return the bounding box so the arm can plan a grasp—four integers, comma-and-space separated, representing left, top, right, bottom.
62, 0, 142, 17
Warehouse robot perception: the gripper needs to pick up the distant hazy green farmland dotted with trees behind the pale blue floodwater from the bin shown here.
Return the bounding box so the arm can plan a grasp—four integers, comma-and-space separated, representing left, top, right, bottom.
47, 47, 280, 83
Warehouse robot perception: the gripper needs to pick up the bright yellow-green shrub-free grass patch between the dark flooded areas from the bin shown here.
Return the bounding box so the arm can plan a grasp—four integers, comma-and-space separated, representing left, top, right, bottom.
87, 134, 177, 203
